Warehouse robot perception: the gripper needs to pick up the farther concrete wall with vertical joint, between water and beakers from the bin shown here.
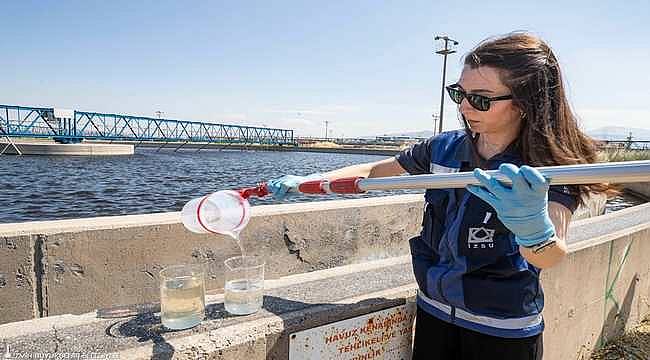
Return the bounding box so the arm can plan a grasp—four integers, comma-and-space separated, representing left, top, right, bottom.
0, 195, 422, 323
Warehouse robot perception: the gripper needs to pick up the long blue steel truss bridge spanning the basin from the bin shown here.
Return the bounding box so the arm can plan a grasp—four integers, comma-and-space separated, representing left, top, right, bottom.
0, 105, 296, 150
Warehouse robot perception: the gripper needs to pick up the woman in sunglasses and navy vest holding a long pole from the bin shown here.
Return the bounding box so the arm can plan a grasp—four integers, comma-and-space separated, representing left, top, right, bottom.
270, 33, 605, 360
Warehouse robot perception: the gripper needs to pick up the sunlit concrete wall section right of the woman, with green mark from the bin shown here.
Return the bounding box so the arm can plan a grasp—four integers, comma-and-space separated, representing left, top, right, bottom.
541, 204, 650, 359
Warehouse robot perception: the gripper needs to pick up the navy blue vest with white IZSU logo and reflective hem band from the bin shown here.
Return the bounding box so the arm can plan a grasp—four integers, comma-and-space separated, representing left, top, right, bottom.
410, 131, 550, 338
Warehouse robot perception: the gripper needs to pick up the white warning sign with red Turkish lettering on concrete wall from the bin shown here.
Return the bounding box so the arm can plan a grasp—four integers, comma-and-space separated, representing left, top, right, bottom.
289, 303, 415, 360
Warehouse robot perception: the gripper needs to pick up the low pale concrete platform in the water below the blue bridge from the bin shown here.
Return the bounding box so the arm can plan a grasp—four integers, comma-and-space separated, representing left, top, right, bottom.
0, 140, 134, 156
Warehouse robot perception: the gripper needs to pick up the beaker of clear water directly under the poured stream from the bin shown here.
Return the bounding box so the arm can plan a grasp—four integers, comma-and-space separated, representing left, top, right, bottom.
224, 256, 264, 315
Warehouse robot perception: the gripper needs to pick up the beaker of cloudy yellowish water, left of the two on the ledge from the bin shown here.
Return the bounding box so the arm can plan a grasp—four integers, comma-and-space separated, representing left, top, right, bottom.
160, 264, 205, 330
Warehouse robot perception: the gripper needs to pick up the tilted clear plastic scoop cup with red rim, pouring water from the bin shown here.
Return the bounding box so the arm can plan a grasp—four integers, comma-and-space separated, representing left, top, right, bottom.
181, 190, 251, 237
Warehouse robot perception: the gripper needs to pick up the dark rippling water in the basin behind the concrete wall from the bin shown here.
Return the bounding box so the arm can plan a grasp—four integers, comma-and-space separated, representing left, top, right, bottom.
0, 148, 642, 223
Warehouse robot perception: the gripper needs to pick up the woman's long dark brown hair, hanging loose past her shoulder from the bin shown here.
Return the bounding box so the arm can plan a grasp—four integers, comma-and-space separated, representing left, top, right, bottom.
465, 32, 610, 202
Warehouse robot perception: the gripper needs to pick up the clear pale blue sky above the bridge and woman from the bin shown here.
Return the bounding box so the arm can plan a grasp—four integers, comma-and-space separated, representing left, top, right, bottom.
0, 0, 650, 137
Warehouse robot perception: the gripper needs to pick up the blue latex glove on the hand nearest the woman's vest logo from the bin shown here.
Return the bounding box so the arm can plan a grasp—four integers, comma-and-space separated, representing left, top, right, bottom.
467, 164, 555, 247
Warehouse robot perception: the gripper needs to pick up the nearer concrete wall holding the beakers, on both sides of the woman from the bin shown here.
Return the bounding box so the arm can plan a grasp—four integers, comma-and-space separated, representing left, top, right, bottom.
0, 204, 650, 360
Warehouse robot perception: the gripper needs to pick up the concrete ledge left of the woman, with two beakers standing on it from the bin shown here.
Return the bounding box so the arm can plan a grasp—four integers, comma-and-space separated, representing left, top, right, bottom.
0, 256, 416, 359
